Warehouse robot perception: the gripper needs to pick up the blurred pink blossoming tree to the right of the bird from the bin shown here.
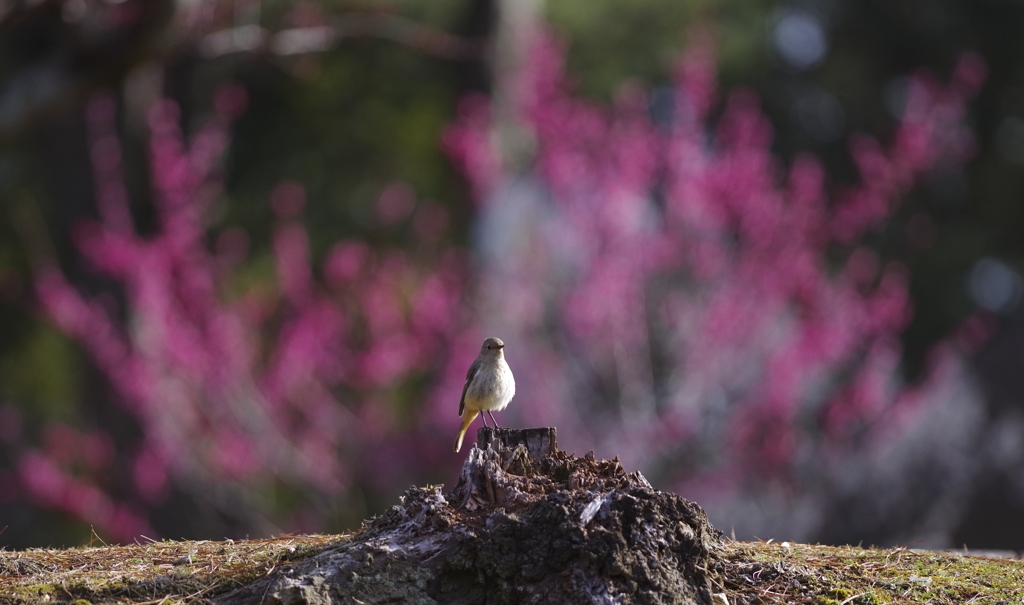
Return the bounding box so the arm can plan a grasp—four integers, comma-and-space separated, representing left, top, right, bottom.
441, 28, 981, 495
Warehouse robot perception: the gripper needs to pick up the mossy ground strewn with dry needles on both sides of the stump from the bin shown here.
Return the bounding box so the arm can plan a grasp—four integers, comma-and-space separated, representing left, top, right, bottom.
0, 535, 1024, 605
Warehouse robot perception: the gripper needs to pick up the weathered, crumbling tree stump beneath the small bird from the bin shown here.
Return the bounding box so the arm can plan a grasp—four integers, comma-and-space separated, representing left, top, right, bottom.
221, 429, 721, 605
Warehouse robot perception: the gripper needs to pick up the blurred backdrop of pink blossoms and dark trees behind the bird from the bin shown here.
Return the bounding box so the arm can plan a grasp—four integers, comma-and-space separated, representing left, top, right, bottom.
0, 0, 1024, 550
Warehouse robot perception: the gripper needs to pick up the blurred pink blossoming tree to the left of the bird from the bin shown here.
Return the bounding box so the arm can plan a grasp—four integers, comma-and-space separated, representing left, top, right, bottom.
25, 87, 465, 541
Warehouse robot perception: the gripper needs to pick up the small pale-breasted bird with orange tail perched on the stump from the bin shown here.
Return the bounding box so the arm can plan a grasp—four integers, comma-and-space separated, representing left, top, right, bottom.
455, 337, 515, 451
